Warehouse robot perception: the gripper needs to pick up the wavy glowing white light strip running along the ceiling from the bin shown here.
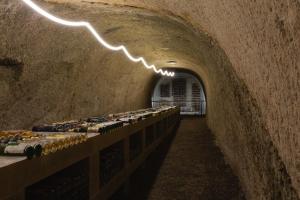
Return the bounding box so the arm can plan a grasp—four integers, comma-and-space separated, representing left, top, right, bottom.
22, 0, 175, 76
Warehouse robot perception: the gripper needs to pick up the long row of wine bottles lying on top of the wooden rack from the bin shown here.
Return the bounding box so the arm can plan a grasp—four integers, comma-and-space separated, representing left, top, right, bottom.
0, 106, 174, 159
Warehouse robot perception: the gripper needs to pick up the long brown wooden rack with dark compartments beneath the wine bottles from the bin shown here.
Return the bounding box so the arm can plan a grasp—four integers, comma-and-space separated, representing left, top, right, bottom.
0, 108, 180, 200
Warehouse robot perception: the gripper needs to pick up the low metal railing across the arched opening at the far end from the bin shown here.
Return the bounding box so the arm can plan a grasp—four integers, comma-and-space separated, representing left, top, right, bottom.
152, 100, 206, 116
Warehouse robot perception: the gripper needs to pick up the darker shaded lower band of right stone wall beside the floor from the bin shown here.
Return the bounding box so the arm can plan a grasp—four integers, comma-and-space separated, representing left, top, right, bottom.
203, 44, 299, 200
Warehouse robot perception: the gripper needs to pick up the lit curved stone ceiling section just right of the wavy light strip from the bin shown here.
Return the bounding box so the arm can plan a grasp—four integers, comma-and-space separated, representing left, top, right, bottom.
40, 1, 210, 81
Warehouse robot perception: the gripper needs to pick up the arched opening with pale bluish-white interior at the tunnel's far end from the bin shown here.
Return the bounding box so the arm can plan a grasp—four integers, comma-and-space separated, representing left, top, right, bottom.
151, 71, 206, 116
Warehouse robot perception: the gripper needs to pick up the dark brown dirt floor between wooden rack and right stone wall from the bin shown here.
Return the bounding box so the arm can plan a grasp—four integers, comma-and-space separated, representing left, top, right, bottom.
113, 118, 245, 200
